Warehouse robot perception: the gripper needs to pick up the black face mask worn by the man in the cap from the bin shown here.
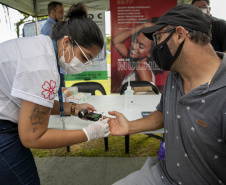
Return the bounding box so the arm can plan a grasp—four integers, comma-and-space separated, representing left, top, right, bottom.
153, 32, 184, 71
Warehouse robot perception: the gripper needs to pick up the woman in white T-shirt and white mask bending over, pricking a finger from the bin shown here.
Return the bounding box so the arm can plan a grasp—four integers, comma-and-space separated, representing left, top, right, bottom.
0, 4, 109, 185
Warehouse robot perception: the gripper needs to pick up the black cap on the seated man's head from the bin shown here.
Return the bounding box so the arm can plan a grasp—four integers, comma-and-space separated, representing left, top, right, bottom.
141, 4, 213, 40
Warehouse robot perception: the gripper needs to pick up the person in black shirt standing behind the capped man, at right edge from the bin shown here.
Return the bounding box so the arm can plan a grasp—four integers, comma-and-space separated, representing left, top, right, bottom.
191, 0, 226, 53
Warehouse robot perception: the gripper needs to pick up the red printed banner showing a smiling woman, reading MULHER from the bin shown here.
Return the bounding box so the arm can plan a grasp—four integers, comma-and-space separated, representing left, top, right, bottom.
110, 0, 177, 93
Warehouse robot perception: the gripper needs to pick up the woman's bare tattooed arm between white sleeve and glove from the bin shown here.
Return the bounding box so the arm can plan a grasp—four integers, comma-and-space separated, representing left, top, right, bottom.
18, 100, 92, 148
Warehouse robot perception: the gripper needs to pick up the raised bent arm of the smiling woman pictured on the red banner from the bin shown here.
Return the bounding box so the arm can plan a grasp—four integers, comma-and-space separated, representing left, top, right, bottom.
112, 22, 153, 58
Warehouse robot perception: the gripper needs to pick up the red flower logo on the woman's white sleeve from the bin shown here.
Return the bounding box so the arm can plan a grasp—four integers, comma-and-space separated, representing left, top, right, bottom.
42, 80, 57, 100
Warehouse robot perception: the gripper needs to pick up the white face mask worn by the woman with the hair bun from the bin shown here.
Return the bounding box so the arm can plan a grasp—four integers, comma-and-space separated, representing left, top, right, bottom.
59, 46, 89, 74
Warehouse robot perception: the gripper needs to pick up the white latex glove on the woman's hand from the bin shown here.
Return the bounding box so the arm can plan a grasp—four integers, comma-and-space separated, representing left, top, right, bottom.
82, 118, 110, 141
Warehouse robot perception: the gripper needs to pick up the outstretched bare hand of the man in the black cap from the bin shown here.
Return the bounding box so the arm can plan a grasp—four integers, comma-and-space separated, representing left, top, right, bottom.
105, 111, 129, 136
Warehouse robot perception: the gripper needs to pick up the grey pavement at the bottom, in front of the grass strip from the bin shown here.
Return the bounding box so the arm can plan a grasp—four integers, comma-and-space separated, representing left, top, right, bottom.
35, 157, 157, 185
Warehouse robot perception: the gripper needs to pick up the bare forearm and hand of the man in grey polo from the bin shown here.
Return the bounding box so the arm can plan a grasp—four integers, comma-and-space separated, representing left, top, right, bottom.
108, 110, 164, 136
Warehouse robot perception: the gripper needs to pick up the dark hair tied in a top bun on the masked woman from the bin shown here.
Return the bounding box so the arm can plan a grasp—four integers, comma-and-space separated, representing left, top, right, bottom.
51, 3, 104, 49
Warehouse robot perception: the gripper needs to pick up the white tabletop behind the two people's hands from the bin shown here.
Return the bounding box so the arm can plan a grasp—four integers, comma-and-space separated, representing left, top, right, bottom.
48, 95, 164, 133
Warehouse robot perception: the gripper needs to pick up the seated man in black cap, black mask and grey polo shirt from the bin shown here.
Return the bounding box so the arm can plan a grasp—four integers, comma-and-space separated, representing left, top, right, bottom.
109, 4, 226, 185
